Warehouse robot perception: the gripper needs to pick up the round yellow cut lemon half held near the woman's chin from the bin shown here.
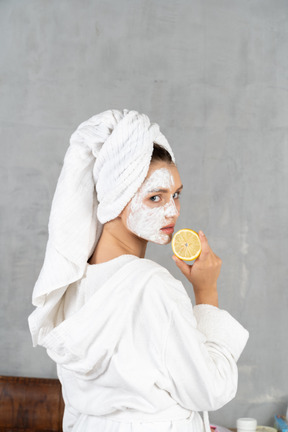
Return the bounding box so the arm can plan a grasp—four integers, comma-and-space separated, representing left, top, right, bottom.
171, 228, 201, 261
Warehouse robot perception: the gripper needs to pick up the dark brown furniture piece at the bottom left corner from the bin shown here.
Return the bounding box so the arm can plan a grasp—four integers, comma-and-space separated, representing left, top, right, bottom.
0, 376, 64, 432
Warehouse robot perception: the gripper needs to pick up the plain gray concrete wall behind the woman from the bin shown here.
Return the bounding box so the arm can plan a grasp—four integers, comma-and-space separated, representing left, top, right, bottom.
0, 0, 288, 427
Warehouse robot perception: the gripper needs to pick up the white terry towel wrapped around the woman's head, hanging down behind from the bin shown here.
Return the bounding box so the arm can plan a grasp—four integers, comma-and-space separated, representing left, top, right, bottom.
29, 109, 174, 345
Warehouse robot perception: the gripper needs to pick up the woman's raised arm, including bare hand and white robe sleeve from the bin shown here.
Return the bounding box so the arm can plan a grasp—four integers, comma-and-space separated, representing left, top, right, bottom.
164, 231, 249, 411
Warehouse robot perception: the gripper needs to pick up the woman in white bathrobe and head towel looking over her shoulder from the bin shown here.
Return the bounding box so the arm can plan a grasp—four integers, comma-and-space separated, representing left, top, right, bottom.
29, 110, 248, 432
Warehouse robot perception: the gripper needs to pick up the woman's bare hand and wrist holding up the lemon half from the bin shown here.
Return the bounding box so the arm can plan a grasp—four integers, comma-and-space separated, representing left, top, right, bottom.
173, 231, 222, 306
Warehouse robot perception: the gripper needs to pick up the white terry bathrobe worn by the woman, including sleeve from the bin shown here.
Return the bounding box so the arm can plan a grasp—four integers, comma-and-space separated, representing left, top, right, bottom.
41, 255, 248, 432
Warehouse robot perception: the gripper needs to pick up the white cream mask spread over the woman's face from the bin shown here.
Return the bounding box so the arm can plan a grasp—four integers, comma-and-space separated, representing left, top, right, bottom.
127, 168, 179, 244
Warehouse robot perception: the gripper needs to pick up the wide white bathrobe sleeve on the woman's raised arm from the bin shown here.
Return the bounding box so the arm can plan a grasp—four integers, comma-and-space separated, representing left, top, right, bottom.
163, 299, 249, 411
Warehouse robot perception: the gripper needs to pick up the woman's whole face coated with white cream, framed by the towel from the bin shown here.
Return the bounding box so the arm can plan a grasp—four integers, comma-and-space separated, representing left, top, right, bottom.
123, 161, 182, 244
